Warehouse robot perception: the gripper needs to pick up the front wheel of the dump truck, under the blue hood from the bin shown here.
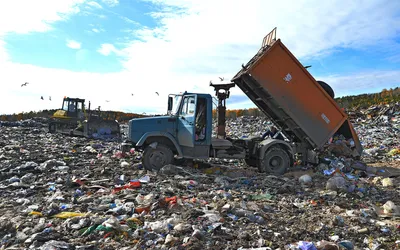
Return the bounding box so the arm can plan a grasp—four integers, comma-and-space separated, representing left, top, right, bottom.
142, 144, 174, 171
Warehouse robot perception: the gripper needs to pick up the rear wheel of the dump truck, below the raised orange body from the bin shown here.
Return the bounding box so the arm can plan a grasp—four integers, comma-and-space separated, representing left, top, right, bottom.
258, 147, 290, 175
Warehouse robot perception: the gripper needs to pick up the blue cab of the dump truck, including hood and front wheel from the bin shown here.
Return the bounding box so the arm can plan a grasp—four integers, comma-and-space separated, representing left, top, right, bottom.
128, 92, 223, 169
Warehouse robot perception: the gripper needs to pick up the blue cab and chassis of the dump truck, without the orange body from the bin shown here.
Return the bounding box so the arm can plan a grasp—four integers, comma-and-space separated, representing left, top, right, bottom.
123, 89, 293, 174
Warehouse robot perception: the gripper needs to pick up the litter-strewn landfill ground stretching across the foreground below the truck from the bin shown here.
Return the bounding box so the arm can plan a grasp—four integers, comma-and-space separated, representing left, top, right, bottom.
0, 112, 400, 250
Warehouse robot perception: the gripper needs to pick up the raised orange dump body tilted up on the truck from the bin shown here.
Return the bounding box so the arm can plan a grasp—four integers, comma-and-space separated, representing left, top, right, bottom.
232, 29, 362, 154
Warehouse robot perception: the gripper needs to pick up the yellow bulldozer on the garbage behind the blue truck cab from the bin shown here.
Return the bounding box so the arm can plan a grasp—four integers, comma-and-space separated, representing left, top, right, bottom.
49, 97, 121, 140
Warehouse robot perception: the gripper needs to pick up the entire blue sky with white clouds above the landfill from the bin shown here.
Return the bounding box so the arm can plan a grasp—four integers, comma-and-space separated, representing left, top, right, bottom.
0, 0, 400, 113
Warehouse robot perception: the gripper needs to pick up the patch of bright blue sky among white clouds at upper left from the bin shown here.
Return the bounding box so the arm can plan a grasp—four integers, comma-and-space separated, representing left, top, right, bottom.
4, 0, 162, 73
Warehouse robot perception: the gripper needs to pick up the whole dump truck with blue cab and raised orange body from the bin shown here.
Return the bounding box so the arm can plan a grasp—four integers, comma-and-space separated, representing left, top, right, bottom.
121, 28, 362, 175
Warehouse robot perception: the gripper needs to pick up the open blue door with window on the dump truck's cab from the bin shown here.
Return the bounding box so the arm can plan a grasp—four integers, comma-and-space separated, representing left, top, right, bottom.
177, 95, 197, 147
